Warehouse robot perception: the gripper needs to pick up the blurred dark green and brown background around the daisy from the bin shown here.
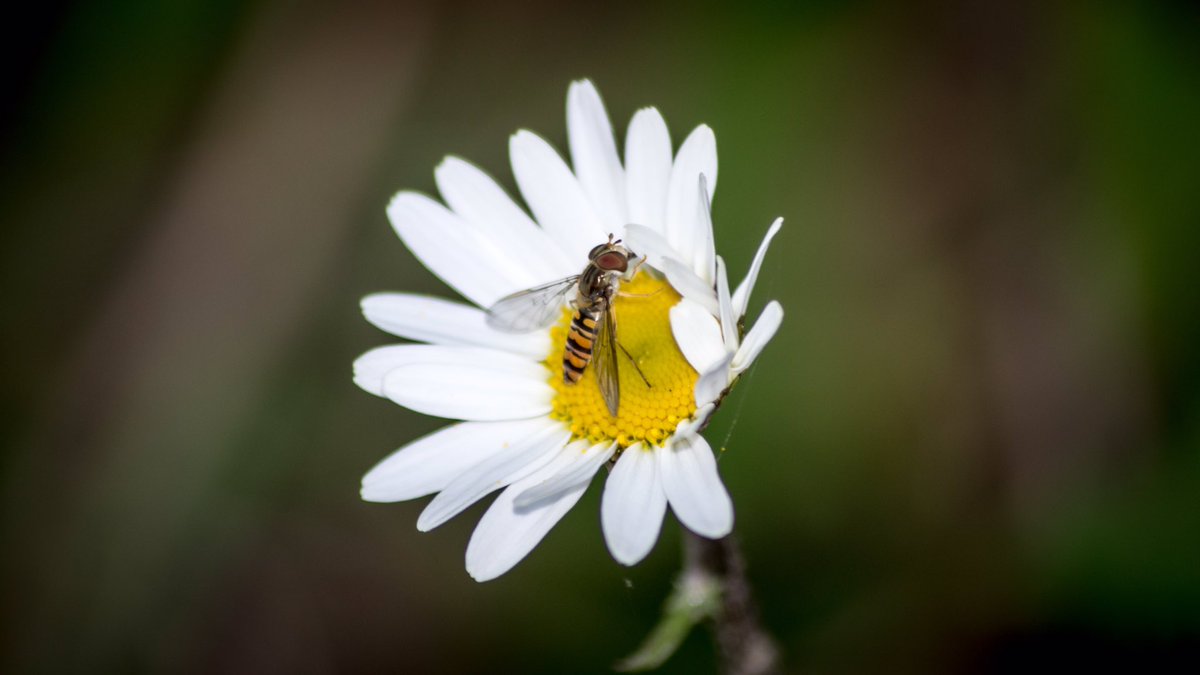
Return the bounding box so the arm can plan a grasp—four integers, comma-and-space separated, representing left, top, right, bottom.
0, 0, 1200, 673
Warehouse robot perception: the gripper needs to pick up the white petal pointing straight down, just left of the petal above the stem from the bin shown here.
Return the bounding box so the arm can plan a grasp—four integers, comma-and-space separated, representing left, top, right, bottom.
600, 444, 667, 565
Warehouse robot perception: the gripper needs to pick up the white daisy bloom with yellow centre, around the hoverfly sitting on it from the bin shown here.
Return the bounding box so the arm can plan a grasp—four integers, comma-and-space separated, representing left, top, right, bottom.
354, 80, 782, 581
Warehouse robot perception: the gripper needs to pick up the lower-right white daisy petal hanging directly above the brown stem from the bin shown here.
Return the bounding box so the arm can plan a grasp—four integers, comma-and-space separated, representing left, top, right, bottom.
655, 435, 733, 539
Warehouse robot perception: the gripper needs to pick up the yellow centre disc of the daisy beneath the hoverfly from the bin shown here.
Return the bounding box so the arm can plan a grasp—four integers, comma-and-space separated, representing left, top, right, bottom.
546, 270, 698, 448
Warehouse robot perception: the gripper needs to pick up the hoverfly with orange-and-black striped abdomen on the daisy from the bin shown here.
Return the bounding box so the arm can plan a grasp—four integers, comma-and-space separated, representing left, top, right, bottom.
487, 234, 649, 417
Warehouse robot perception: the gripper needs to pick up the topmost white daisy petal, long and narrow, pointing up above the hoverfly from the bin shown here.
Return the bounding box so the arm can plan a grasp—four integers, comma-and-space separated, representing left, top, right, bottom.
566, 79, 629, 232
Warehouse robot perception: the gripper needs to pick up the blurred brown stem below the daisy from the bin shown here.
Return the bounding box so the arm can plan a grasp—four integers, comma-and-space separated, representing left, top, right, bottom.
682, 531, 780, 675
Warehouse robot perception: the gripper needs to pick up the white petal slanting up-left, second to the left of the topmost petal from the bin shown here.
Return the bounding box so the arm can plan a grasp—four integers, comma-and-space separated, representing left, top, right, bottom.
434, 157, 578, 286
